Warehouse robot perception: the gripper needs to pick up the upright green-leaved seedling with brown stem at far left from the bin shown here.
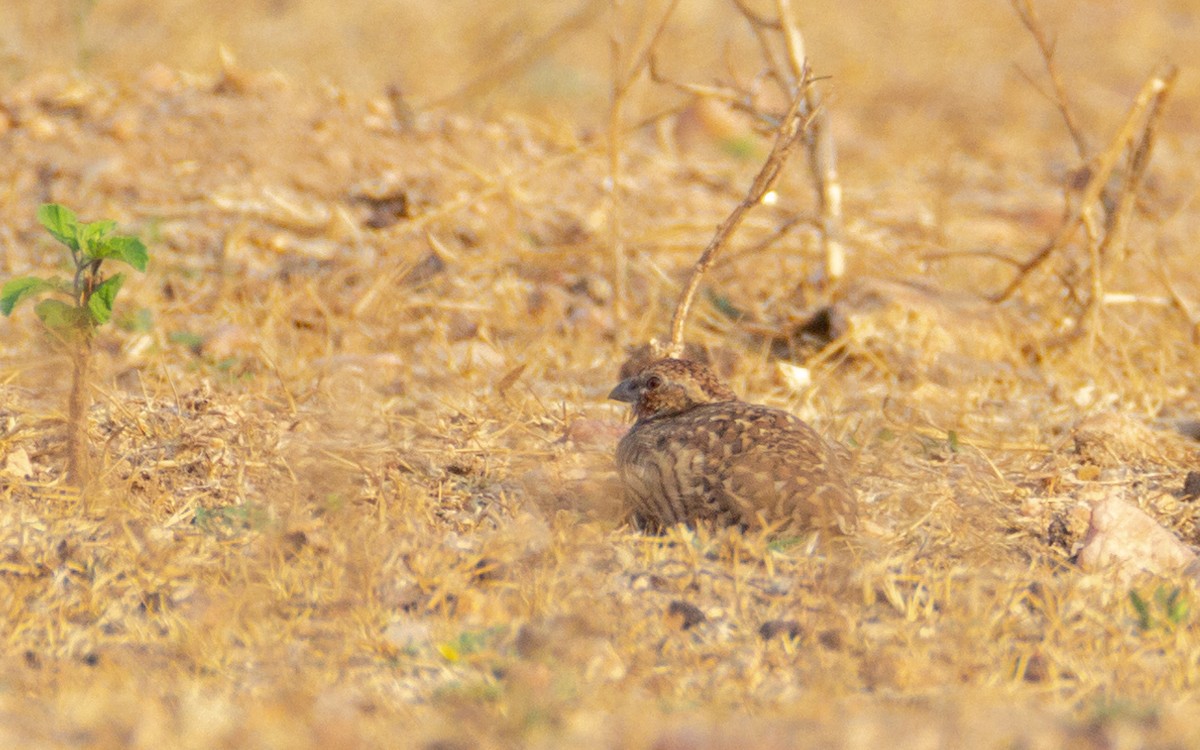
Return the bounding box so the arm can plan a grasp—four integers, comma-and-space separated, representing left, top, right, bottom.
0, 203, 149, 485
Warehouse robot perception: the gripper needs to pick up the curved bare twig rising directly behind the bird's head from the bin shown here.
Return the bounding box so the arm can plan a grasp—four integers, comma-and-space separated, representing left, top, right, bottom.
666, 90, 811, 356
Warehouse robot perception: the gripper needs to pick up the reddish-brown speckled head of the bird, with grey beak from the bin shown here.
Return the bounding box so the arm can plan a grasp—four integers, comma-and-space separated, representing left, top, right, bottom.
608, 358, 737, 420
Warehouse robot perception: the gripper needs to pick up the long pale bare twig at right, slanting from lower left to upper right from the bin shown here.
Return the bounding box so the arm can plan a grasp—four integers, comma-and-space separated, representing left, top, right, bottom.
991, 66, 1177, 302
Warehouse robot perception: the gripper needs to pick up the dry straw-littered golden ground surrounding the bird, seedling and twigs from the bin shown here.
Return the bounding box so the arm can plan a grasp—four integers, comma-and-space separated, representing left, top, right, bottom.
0, 0, 1200, 750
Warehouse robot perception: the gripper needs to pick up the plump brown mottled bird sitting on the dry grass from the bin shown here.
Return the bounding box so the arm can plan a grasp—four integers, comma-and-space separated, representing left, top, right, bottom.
608, 358, 858, 538
